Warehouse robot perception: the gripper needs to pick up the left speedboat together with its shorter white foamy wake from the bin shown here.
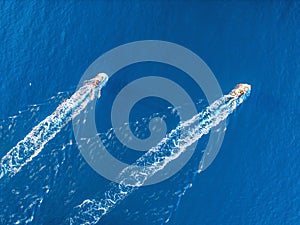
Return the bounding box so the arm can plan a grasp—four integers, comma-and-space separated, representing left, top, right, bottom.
0, 73, 108, 179
